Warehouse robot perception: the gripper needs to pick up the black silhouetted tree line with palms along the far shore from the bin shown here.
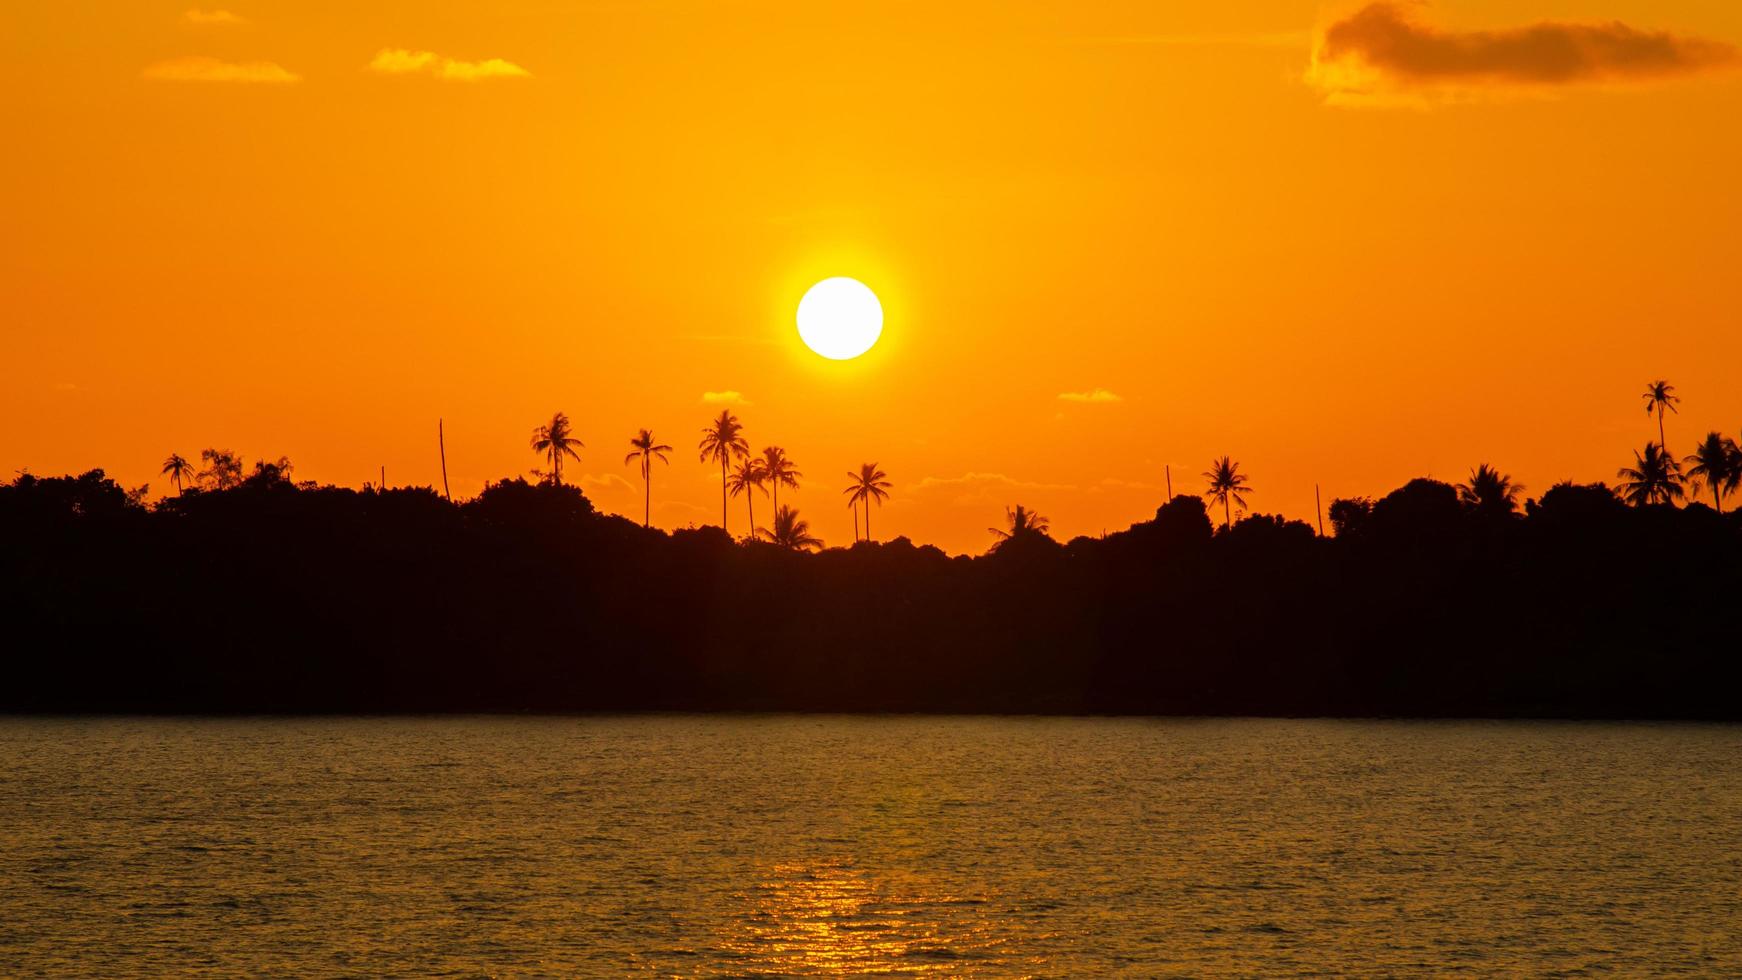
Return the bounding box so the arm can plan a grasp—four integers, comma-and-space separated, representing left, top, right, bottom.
0, 383, 1742, 719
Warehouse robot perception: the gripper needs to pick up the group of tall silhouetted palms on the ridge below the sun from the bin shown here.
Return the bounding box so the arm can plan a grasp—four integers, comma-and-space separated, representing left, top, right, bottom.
522, 409, 894, 550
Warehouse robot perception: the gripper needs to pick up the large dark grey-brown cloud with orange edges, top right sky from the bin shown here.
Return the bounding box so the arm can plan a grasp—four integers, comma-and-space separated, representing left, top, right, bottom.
1307, 0, 1739, 103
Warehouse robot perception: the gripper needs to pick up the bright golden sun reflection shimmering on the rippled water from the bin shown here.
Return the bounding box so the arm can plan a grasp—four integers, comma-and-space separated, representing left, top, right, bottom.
721, 860, 1005, 977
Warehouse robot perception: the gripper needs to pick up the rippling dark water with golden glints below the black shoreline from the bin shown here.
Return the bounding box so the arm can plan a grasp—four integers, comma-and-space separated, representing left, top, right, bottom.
0, 717, 1742, 977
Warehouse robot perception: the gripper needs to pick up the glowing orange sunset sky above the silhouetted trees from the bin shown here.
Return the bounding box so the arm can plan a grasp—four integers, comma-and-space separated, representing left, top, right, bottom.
0, 0, 1742, 552
